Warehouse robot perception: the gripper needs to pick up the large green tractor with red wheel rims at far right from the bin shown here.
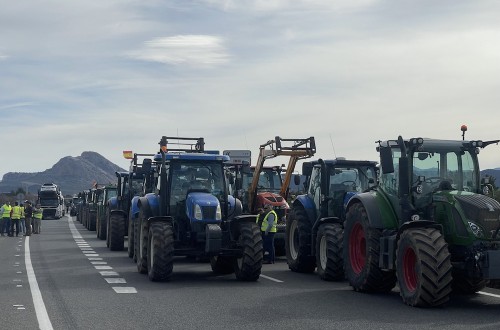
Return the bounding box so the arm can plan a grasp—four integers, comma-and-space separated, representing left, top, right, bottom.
343, 136, 500, 307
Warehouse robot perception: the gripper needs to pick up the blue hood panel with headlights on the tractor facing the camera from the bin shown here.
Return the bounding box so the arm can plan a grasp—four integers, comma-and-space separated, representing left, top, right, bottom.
186, 192, 221, 223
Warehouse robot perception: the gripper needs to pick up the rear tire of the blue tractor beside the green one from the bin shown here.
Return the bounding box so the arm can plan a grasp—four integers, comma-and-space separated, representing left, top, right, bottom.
285, 206, 316, 273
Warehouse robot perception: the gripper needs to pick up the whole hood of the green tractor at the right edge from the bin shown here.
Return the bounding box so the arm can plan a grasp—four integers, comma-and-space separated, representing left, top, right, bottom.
434, 191, 500, 240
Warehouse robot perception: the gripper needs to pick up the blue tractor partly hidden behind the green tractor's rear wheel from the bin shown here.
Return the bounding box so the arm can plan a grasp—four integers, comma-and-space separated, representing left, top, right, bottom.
285, 158, 377, 281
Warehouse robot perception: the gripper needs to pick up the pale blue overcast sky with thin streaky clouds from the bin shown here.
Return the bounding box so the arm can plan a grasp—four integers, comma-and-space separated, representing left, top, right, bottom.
0, 0, 500, 183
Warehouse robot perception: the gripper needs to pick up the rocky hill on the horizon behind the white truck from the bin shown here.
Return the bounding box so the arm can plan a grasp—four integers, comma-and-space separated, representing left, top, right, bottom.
0, 151, 124, 195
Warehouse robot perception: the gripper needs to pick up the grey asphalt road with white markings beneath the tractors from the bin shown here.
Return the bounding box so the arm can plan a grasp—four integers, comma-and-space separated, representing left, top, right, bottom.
0, 217, 500, 330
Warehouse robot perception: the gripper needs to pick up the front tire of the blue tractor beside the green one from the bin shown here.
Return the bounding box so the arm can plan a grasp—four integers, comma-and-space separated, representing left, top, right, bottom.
316, 223, 345, 281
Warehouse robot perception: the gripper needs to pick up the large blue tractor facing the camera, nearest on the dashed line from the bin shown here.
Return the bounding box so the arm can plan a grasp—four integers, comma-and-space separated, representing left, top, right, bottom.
135, 136, 263, 281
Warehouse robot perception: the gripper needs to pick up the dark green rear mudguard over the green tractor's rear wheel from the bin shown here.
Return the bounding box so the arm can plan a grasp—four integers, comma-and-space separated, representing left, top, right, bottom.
346, 191, 398, 229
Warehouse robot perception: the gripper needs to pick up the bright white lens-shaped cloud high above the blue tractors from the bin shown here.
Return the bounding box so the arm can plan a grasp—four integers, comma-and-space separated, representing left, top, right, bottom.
128, 35, 229, 67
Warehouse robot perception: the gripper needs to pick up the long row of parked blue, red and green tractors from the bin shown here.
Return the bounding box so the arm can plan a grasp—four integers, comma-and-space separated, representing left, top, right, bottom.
72, 131, 500, 307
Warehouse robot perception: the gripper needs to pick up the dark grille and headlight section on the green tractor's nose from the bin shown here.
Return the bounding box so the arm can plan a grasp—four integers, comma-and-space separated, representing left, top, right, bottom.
456, 195, 500, 238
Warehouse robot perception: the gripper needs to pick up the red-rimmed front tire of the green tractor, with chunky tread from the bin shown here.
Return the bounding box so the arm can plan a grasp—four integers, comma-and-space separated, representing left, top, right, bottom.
396, 228, 452, 307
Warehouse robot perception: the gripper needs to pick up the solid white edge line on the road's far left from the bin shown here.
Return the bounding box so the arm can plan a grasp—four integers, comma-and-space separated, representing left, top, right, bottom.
24, 236, 54, 330
